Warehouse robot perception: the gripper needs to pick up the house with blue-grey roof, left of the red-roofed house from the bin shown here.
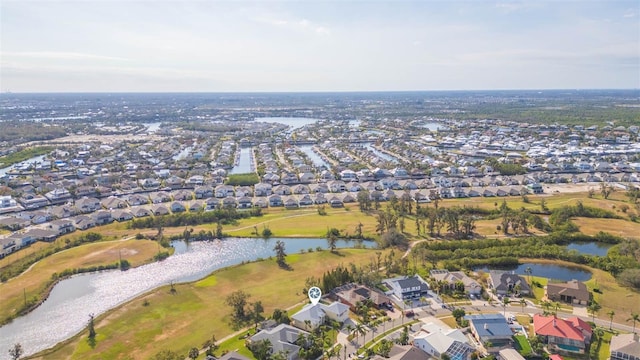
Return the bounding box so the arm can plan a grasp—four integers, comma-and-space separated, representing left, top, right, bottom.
464, 314, 513, 352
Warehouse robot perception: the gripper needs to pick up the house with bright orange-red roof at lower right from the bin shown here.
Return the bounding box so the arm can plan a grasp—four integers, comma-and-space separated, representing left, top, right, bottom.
533, 314, 593, 354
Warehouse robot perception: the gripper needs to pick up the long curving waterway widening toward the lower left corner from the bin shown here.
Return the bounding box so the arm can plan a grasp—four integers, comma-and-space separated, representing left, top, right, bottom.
0, 238, 366, 360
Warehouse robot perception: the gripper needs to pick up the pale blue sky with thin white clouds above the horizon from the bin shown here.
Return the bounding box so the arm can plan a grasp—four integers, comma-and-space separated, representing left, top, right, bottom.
0, 0, 640, 92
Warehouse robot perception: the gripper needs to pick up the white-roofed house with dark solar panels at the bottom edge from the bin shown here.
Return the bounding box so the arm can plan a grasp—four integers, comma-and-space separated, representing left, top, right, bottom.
413, 322, 474, 360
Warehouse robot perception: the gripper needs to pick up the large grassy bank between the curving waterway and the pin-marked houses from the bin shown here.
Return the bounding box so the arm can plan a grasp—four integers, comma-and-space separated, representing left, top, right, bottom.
33, 249, 390, 359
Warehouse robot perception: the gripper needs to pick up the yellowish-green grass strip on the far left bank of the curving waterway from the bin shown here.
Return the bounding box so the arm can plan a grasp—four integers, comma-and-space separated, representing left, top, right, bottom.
0, 240, 158, 319
